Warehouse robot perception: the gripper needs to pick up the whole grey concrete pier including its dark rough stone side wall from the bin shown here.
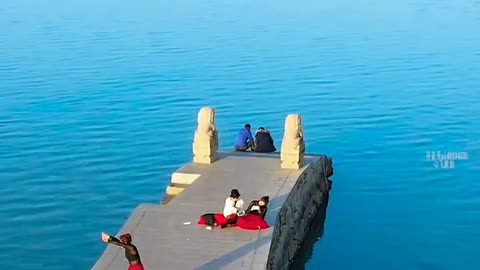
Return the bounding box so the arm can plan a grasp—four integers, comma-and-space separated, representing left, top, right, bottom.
92, 110, 333, 270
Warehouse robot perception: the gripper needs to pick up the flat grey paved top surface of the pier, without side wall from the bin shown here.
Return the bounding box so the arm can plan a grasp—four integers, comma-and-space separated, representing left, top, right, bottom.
92, 152, 321, 270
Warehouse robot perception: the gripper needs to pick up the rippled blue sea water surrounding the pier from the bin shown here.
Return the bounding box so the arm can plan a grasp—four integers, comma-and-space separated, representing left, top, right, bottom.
0, 0, 480, 270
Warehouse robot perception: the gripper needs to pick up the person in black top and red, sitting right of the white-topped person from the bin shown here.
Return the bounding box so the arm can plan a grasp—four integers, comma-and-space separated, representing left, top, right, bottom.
236, 196, 270, 230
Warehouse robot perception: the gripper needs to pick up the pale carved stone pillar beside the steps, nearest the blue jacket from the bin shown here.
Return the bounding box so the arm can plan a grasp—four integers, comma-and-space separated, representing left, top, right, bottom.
193, 107, 218, 164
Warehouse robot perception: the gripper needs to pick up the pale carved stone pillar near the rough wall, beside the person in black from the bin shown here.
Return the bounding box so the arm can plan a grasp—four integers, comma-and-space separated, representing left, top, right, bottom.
280, 114, 305, 169
